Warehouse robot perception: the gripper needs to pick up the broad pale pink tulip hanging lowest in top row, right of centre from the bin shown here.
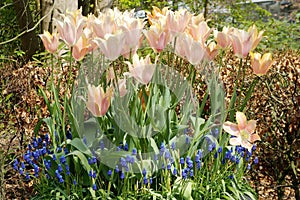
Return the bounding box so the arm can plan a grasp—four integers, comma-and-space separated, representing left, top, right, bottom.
175, 33, 206, 65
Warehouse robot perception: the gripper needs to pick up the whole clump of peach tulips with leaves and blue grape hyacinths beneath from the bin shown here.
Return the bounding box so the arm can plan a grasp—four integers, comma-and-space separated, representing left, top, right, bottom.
5, 8, 282, 199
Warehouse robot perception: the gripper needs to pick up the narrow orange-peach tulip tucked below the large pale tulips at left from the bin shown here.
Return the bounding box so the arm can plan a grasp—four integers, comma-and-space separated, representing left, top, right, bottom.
72, 34, 90, 61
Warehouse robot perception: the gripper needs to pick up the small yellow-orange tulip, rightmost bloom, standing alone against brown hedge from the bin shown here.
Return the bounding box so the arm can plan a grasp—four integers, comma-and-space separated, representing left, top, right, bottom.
250, 52, 274, 76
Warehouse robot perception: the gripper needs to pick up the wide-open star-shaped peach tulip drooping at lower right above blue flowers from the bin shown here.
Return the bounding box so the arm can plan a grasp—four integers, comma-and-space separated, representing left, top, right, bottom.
223, 112, 260, 151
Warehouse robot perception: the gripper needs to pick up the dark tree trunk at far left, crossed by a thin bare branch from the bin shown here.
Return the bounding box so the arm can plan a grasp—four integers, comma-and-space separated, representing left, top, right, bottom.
14, 0, 39, 61
